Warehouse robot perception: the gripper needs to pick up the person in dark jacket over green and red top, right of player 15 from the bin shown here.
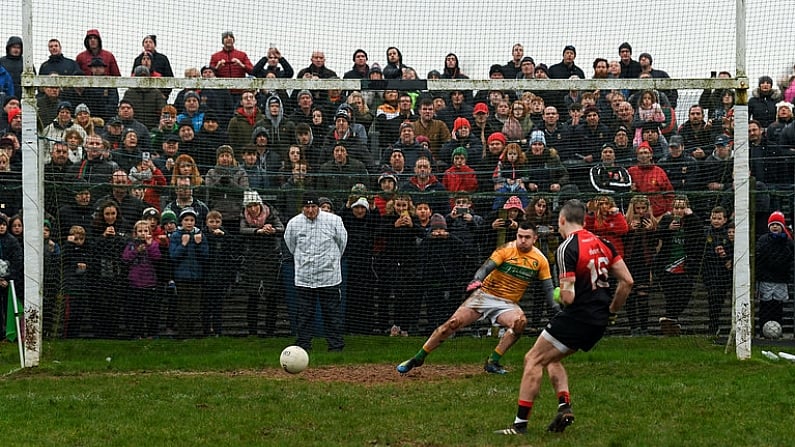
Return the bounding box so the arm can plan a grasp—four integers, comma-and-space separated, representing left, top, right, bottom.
652, 196, 704, 335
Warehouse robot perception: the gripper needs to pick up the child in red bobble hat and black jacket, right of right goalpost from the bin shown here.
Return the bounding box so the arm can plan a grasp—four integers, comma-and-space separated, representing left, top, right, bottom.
755, 211, 795, 334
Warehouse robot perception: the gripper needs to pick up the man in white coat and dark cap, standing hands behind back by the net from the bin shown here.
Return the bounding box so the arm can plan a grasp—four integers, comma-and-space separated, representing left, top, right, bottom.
284, 199, 348, 351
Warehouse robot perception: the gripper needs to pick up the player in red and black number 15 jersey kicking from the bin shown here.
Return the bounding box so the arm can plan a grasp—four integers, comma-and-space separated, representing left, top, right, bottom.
496, 200, 633, 435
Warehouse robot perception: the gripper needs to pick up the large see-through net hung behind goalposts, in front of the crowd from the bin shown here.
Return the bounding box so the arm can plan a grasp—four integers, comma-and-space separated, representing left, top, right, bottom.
0, 0, 794, 366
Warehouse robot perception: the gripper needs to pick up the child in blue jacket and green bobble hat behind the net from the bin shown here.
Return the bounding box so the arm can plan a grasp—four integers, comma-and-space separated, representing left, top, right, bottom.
168, 207, 209, 338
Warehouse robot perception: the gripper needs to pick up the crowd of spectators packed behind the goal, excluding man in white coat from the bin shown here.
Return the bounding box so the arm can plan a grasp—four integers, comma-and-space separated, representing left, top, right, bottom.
0, 34, 795, 344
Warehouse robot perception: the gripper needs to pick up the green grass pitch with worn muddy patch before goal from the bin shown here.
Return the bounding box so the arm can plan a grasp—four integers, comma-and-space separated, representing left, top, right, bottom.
0, 336, 795, 447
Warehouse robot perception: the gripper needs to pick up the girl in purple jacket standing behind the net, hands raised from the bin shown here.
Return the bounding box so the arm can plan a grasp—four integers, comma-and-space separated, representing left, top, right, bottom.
122, 220, 161, 339
